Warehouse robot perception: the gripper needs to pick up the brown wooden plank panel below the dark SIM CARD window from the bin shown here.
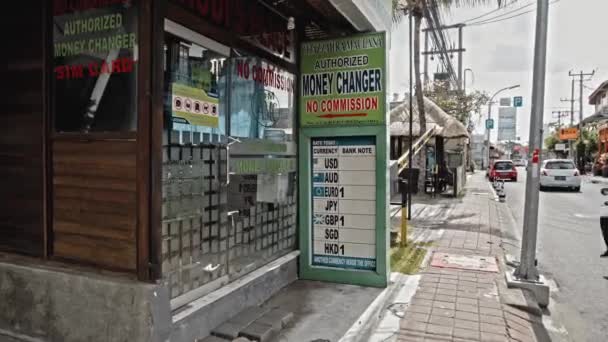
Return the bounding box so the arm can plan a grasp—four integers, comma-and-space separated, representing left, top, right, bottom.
53, 140, 137, 272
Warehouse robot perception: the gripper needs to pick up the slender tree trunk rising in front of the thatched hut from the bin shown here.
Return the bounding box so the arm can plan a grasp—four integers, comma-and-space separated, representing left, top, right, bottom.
414, 13, 426, 192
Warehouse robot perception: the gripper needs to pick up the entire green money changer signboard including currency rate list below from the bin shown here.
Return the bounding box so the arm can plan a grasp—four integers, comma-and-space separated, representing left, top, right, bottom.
298, 32, 390, 287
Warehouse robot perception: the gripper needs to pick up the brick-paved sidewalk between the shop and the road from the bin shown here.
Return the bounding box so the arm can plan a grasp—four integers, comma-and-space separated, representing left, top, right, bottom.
397, 172, 548, 342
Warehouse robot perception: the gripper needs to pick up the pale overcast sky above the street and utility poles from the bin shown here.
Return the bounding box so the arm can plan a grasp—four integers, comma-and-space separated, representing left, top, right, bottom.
389, 0, 608, 142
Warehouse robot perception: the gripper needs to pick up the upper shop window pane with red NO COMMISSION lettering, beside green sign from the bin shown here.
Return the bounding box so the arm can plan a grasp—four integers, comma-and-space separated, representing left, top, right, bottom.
230, 52, 295, 142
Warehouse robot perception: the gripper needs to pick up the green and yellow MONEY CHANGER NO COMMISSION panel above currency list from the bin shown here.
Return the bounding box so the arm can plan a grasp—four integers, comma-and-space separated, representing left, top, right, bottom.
300, 32, 386, 127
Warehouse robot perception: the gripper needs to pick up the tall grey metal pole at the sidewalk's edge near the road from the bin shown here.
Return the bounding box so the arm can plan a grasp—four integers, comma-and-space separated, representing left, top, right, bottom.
514, 0, 549, 282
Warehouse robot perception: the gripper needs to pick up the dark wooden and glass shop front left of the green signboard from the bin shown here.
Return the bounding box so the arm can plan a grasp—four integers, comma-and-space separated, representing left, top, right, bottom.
0, 0, 390, 341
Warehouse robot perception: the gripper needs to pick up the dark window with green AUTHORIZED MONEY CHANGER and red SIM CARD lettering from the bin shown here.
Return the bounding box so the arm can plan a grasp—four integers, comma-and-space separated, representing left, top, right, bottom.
52, 0, 138, 132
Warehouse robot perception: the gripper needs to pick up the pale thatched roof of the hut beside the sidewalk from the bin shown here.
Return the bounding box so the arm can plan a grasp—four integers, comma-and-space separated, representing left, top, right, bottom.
390, 97, 469, 139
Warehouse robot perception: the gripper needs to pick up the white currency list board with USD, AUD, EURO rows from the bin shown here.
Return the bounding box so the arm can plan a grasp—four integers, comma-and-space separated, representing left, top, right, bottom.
311, 136, 376, 270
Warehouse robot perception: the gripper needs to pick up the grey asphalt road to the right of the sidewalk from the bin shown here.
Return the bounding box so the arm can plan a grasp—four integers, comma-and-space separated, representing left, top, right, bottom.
505, 169, 608, 342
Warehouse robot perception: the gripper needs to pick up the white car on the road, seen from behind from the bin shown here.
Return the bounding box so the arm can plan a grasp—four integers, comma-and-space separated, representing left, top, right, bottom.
540, 159, 581, 191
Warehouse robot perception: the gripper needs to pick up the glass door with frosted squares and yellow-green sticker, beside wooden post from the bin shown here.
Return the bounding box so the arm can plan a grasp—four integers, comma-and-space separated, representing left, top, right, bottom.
162, 21, 230, 307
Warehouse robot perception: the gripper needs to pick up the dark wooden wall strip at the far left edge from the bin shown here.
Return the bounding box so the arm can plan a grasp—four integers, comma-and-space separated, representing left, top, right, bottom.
0, 0, 45, 255
